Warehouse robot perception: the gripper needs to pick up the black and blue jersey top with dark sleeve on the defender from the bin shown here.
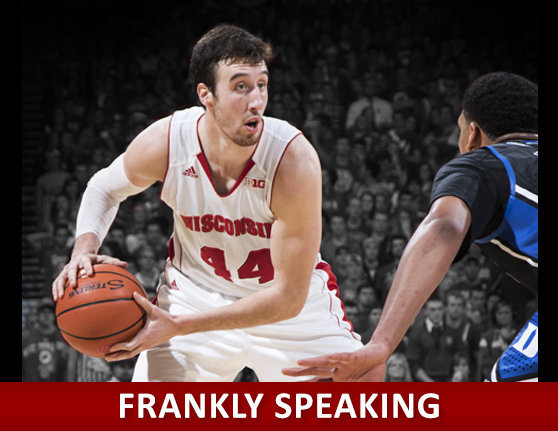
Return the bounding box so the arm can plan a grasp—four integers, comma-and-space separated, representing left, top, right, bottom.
431, 141, 539, 294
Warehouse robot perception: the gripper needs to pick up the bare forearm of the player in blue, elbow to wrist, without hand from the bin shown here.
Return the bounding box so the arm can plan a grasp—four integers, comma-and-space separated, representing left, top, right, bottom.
370, 211, 467, 353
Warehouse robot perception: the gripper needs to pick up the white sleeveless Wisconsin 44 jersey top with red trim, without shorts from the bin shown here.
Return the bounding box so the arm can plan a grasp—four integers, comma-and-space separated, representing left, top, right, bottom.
161, 107, 306, 298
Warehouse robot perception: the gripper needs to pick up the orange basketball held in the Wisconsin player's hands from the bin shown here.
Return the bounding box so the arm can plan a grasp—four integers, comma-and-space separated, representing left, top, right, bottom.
56, 264, 147, 357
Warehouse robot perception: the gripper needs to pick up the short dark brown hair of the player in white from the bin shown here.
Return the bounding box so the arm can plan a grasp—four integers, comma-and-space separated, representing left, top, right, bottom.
190, 24, 273, 92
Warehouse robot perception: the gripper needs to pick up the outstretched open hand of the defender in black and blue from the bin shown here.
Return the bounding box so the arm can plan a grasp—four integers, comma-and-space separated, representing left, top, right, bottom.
282, 344, 388, 382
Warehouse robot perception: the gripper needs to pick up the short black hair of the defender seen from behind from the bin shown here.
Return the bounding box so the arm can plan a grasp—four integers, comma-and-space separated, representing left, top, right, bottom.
462, 72, 539, 140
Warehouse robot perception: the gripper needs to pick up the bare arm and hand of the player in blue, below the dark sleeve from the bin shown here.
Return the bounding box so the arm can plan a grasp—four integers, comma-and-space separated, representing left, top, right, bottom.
283, 196, 471, 381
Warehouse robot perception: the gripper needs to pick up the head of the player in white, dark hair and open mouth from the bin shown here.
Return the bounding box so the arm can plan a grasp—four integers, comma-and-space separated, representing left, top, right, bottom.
190, 24, 273, 146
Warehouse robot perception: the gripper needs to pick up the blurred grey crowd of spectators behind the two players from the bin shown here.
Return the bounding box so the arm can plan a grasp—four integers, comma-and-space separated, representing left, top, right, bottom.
23, 0, 537, 381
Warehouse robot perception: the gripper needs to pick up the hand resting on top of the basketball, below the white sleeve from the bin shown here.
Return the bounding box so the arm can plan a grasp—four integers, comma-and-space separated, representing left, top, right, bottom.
52, 253, 128, 301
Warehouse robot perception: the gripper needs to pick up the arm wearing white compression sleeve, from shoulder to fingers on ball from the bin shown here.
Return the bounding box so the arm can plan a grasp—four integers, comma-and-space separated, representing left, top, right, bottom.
52, 117, 170, 301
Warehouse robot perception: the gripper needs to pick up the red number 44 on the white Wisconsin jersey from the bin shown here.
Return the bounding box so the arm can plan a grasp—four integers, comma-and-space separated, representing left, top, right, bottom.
200, 246, 273, 284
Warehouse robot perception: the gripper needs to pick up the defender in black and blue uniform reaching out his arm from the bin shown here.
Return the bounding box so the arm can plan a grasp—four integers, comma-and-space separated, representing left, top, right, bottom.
283, 72, 539, 381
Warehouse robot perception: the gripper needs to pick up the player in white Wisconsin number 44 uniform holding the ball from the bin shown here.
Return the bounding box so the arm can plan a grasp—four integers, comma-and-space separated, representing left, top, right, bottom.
52, 25, 362, 381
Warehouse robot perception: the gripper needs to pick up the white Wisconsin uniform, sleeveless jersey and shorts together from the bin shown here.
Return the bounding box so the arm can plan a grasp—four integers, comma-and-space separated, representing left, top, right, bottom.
132, 107, 362, 382
